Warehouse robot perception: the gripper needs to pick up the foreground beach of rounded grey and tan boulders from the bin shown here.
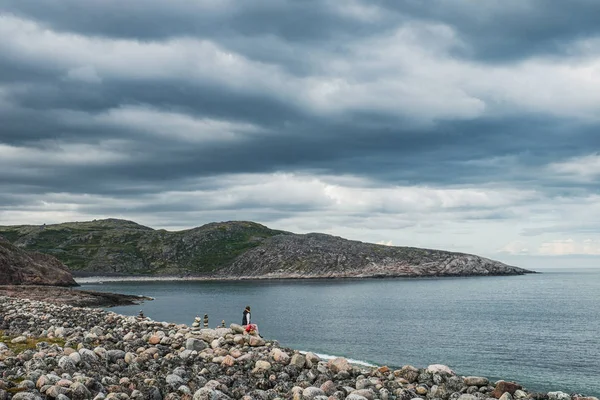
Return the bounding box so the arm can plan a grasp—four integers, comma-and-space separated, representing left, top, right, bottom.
0, 296, 597, 400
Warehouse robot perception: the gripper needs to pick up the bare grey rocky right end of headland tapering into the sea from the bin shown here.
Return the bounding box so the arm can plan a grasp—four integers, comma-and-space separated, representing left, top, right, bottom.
217, 233, 530, 278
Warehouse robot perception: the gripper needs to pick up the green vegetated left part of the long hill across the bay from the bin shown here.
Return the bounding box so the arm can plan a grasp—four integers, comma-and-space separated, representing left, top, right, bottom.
0, 219, 287, 274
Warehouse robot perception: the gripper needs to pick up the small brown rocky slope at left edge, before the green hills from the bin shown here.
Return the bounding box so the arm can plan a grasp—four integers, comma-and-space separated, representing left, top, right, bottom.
0, 236, 77, 286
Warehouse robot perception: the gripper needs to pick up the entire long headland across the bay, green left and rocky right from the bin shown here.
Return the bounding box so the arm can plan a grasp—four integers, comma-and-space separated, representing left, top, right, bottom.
0, 219, 532, 278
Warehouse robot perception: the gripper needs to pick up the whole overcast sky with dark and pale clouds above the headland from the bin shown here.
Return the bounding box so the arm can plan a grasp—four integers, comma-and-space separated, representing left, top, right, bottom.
0, 0, 600, 267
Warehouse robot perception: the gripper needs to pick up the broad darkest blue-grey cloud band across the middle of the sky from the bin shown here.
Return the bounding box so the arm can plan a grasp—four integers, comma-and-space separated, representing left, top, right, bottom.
0, 86, 598, 199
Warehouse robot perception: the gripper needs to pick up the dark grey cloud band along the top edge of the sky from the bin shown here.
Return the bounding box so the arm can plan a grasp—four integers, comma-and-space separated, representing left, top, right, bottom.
0, 0, 600, 65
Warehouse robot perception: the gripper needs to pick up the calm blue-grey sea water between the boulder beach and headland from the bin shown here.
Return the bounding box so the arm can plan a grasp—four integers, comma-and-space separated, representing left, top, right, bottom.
83, 269, 600, 396
